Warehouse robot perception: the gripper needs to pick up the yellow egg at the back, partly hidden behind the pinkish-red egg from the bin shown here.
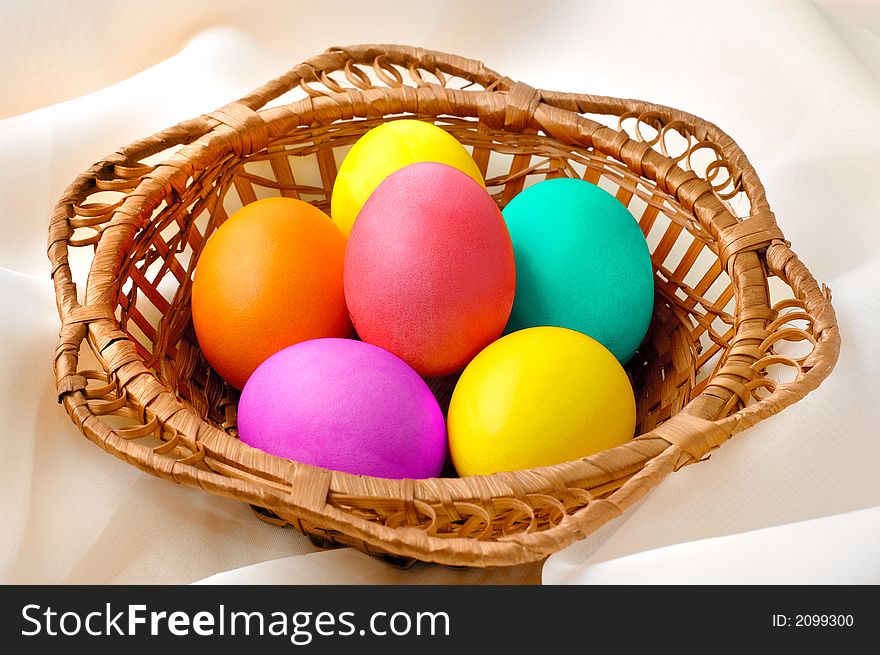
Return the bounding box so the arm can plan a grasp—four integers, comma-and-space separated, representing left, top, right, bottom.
330, 119, 485, 235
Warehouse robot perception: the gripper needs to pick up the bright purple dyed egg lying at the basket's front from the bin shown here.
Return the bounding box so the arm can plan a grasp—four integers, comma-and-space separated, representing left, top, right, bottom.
238, 339, 446, 478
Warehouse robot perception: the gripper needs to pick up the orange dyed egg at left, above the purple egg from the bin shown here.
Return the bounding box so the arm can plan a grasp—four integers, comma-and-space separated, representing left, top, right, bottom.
192, 198, 352, 389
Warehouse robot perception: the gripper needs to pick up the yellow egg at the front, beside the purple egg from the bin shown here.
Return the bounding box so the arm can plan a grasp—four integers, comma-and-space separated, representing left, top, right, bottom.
447, 327, 636, 476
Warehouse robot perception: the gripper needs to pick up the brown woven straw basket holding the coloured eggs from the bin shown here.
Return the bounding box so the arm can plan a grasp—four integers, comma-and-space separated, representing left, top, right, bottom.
48, 45, 840, 566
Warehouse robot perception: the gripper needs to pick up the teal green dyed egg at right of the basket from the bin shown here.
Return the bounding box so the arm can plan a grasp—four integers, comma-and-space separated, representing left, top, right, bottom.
502, 178, 654, 363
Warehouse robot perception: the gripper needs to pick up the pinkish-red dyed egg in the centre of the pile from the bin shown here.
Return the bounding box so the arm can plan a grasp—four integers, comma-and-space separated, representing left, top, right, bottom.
345, 162, 516, 377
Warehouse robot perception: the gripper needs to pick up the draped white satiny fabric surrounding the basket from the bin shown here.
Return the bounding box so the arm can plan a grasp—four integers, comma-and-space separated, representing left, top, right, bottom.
0, 0, 880, 583
